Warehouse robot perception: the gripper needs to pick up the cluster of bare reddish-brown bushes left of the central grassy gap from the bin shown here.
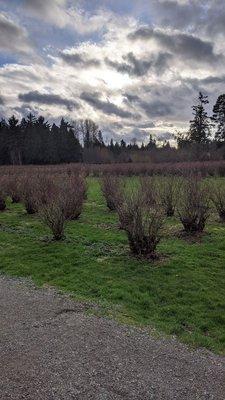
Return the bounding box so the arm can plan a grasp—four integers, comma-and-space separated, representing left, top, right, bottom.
0, 174, 86, 240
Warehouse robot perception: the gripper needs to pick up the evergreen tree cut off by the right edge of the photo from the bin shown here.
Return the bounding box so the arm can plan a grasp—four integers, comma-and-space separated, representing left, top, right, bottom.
212, 94, 225, 142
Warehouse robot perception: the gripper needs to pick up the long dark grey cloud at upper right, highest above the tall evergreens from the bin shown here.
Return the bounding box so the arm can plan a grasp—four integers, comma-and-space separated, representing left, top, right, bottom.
128, 27, 220, 62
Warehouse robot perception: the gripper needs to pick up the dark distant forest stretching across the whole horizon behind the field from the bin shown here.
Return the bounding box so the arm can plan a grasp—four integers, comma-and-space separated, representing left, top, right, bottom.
0, 92, 225, 165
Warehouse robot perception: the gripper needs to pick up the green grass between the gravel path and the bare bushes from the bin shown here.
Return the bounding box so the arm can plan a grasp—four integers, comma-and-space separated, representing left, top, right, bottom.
0, 179, 225, 353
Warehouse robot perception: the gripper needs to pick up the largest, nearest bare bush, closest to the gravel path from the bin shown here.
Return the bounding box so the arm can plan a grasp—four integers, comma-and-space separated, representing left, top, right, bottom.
117, 188, 164, 259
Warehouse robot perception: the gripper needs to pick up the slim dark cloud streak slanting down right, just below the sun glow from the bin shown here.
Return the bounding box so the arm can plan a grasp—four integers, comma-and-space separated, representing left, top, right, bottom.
80, 92, 133, 118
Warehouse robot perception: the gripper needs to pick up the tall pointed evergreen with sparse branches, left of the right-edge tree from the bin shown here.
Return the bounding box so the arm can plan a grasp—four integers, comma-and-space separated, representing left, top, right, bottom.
189, 92, 211, 144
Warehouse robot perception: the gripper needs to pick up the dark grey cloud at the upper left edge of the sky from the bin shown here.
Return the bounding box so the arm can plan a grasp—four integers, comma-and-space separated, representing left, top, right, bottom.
0, 13, 31, 53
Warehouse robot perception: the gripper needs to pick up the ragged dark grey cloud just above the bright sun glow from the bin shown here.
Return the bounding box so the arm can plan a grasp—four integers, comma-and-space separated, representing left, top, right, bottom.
105, 52, 172, 77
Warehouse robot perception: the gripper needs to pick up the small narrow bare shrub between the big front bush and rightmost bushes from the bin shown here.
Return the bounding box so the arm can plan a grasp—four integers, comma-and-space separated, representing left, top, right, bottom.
158, 176, 180, 217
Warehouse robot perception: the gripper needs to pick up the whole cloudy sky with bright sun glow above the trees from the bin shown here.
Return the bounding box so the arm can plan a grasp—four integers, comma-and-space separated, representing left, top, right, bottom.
0, 0, 225, 142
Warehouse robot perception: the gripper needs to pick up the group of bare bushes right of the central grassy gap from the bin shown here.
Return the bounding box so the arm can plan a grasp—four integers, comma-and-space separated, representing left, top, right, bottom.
101, 175, 225, 258
